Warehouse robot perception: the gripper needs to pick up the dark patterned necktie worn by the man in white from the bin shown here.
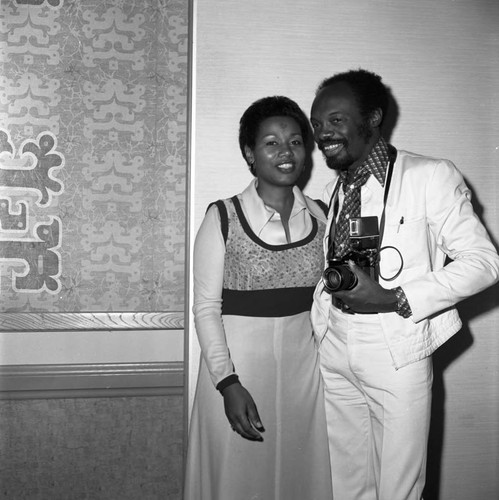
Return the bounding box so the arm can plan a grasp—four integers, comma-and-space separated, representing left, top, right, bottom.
331, 165, 371, 258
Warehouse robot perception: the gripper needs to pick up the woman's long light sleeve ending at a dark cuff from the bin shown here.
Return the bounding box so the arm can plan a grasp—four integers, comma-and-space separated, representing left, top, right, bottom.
193, 205, 234, 386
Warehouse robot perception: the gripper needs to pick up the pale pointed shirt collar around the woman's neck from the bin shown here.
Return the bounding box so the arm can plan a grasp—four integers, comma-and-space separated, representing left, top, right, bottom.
241, 179, 309, 234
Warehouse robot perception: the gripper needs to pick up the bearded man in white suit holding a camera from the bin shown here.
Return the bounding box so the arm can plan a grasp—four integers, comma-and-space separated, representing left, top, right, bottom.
311, 69, 499, 500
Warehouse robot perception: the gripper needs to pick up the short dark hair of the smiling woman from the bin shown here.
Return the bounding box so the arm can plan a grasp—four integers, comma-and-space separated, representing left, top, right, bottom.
239, 96, 310, 174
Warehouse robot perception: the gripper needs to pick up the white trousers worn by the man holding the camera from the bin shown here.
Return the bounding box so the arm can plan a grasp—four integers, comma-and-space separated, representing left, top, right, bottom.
319, 307, 433, 500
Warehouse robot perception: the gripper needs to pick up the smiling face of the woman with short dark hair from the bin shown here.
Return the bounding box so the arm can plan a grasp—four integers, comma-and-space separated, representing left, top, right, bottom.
245, 116, 305, 187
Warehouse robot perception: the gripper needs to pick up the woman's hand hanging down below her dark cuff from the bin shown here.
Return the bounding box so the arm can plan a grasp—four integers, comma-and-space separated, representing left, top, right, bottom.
222, 383, 265, 441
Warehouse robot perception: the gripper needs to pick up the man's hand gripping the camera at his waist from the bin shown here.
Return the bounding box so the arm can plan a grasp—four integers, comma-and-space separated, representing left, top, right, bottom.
331, 261, 397, 313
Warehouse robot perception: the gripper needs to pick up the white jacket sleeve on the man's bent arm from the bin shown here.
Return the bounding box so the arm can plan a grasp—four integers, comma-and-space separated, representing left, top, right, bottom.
401, 161, 499, 322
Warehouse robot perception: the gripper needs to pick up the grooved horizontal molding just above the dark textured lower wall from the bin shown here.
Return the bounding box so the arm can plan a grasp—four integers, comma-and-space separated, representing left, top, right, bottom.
0, 361, 184, 399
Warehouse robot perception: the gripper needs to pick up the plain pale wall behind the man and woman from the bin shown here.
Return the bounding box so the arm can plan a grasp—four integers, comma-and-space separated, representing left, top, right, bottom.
189, 0, 499, 500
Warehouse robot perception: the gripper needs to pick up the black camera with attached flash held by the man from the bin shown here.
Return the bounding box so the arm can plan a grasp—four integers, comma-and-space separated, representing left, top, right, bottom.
322, 216, 379, 293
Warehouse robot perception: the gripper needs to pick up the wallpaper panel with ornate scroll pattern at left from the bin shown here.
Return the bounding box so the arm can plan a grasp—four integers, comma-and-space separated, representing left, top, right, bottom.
0, 0, 188, 312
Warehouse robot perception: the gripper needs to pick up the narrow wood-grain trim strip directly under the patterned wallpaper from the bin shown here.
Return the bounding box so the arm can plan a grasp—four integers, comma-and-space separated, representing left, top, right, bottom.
0, 311, 185, 332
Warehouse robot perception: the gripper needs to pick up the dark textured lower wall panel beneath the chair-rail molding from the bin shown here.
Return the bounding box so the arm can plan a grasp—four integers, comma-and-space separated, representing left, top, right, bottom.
0, 396, 183, 500
